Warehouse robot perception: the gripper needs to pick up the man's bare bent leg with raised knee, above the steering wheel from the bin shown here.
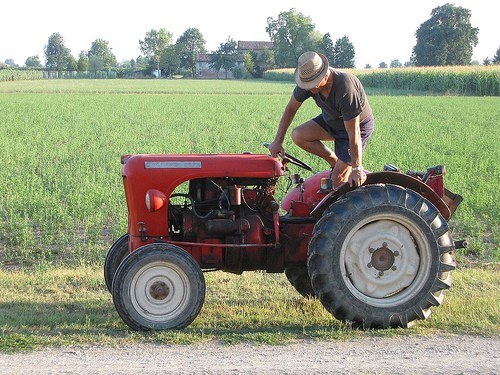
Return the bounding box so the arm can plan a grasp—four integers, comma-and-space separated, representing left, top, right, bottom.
292, 120, 338, 167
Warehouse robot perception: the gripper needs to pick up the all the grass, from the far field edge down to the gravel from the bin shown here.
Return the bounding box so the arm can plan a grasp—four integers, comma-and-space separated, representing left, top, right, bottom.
0, 80, 500, 351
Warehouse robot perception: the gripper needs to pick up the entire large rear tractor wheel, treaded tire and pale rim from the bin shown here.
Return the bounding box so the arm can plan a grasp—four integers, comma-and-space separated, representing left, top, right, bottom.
308, 185, 455, 328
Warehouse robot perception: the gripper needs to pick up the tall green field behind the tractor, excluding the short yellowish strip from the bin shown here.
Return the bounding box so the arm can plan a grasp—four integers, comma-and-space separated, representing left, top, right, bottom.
0, 80, 500, 265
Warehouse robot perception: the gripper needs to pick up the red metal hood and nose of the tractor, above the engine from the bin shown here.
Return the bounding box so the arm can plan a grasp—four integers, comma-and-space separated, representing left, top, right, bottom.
121, 154, 285, 242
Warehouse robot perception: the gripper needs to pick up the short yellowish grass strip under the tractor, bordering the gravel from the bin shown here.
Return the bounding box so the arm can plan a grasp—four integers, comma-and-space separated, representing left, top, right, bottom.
0, 267, 500, 352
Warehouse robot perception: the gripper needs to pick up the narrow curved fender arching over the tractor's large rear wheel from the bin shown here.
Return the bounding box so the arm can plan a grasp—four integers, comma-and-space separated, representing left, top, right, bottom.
311, 171, 451, 220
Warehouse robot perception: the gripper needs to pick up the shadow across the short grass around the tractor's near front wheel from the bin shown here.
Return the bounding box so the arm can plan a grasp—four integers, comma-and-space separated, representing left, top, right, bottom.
0, 299, 356, 353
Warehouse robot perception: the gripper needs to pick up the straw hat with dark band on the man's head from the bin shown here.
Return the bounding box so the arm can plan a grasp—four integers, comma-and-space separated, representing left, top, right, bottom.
295, 51, 328, 90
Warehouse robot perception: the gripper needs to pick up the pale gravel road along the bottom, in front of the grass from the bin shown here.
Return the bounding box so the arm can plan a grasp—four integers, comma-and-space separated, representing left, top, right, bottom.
0, 336, 500, 375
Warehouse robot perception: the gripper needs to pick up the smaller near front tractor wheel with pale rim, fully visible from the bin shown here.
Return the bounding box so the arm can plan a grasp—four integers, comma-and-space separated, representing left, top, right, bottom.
113, 244, 205, 331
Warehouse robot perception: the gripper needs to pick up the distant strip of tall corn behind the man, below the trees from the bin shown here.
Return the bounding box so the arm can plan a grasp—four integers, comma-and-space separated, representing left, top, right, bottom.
264, 65, 500, 96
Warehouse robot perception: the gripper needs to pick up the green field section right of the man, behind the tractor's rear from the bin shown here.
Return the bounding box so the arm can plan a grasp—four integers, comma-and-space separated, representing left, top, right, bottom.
365, 96, 500, 261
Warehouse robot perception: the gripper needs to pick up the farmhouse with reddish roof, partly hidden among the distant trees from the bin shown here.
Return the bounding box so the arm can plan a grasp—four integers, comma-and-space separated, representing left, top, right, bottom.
196, 40, 273, 79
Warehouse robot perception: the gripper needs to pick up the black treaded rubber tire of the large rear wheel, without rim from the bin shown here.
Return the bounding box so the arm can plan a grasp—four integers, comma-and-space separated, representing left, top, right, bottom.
308, 185, 455, 328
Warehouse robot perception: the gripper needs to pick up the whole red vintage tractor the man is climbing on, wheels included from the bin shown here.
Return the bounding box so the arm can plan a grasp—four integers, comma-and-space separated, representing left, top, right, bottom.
104, 145, 465, 330
